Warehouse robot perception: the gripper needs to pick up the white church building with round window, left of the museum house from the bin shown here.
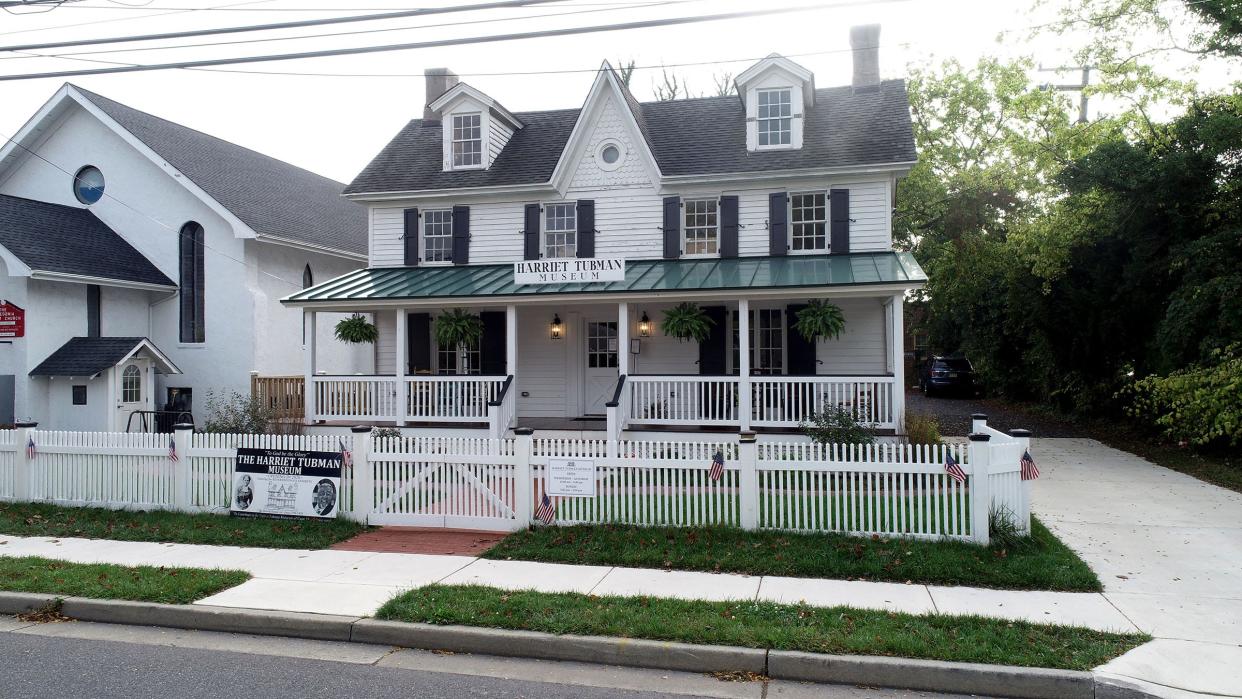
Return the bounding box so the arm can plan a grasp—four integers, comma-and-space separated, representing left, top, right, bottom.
0, 84, 374, 431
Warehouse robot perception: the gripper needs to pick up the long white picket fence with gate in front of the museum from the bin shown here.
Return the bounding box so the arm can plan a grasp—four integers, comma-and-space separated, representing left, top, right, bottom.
0, 418, 1030, 543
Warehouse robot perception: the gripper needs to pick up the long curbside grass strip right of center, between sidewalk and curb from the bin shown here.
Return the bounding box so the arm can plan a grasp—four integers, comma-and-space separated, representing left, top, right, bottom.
376, 585, 1150, 670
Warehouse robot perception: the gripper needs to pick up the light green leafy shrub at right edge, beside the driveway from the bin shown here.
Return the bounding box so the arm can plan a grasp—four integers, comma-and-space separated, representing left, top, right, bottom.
1123, 344, 1242, 447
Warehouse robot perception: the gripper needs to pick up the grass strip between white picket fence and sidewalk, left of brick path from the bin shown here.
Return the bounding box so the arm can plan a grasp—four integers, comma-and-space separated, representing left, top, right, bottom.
0, 503, 366, 549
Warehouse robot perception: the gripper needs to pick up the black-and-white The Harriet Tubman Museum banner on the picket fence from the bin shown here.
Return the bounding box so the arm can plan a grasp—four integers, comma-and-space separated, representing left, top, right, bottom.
229, 448, 342, 519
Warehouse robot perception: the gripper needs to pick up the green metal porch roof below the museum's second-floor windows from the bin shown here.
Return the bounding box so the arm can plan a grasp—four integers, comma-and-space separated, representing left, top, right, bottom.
282, 252, 928, 305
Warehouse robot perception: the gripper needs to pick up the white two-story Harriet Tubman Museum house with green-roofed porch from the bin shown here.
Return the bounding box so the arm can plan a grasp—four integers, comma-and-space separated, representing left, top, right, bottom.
284, 26, 925, 436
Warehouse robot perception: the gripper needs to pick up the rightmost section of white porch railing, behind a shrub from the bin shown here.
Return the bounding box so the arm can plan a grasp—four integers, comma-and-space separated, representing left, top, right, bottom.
750, 376, 897, 430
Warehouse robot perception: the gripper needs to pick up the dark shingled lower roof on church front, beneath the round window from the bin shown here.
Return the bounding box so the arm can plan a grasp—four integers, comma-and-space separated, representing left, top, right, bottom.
0, 194, 176, 287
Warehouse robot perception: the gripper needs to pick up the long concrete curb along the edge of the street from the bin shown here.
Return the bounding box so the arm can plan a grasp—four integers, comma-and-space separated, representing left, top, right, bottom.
0, 592, 1155, 699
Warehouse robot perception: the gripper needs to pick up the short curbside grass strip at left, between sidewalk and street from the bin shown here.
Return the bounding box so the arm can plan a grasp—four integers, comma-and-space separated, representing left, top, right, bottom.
0, 556, 250, 605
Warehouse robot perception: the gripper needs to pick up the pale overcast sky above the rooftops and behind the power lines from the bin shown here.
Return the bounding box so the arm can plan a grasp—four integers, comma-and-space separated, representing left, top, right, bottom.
0, 0, 1238, 181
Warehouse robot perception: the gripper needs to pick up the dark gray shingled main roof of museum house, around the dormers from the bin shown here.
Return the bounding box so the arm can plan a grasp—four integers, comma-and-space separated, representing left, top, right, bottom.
345, 79, 917, 194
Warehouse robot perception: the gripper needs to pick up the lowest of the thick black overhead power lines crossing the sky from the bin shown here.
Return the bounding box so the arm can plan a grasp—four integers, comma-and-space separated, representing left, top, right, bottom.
0, 0, 909, 82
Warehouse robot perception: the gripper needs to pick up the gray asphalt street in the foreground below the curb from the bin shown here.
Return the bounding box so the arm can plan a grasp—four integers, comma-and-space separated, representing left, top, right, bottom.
0, 617, 983, 699
